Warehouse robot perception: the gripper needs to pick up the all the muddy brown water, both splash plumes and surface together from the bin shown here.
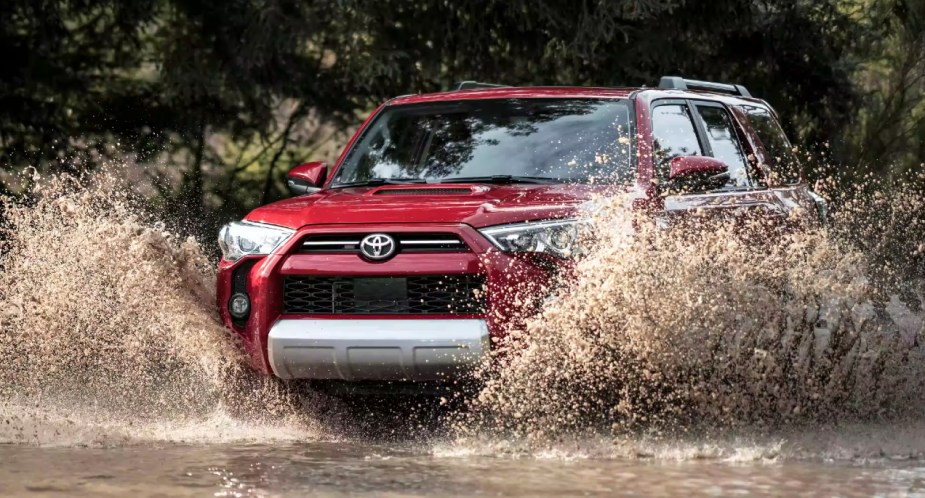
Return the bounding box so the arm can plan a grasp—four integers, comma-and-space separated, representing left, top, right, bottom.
0, 170, 925, 496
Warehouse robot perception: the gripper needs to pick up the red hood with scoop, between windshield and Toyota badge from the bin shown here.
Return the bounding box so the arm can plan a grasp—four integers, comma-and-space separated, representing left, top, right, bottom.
245, 184, 616, 228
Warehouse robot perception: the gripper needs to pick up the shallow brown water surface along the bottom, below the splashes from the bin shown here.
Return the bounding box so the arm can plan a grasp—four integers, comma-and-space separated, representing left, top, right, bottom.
0, 442, 925, 497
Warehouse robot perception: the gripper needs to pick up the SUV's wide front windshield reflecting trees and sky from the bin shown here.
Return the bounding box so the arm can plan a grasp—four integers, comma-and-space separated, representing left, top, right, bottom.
331, 99, 635, 187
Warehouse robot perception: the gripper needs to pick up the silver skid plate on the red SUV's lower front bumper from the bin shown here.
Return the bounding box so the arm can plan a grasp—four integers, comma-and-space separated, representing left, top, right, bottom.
267, 319, 489, 381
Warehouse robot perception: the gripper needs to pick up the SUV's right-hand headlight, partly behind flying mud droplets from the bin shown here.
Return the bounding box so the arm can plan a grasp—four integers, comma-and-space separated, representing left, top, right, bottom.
479, 220, 584, 258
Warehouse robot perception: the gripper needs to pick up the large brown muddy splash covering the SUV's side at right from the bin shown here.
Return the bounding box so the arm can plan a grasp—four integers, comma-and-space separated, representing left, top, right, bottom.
453, 187, 925, 454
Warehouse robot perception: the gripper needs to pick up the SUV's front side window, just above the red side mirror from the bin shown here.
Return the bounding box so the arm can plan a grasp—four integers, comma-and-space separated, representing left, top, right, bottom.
652, 104, 703, 181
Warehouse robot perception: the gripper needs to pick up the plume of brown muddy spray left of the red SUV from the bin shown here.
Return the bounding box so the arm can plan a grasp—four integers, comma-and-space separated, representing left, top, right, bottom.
0, 174, 334, 444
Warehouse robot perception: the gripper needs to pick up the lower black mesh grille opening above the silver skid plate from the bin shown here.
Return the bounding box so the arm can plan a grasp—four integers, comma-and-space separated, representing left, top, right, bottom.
283, 274, 485, 315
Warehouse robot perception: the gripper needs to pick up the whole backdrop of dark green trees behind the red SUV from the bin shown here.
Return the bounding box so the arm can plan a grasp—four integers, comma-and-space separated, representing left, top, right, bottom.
0, 0, 925, 226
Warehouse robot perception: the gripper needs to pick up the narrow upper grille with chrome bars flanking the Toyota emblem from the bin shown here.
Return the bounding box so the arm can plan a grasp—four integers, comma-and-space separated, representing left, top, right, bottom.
299, 232, 469, 254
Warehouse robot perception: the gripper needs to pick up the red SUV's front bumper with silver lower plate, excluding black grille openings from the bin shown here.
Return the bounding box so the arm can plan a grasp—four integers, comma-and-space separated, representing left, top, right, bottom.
216, 224, 553, 381
